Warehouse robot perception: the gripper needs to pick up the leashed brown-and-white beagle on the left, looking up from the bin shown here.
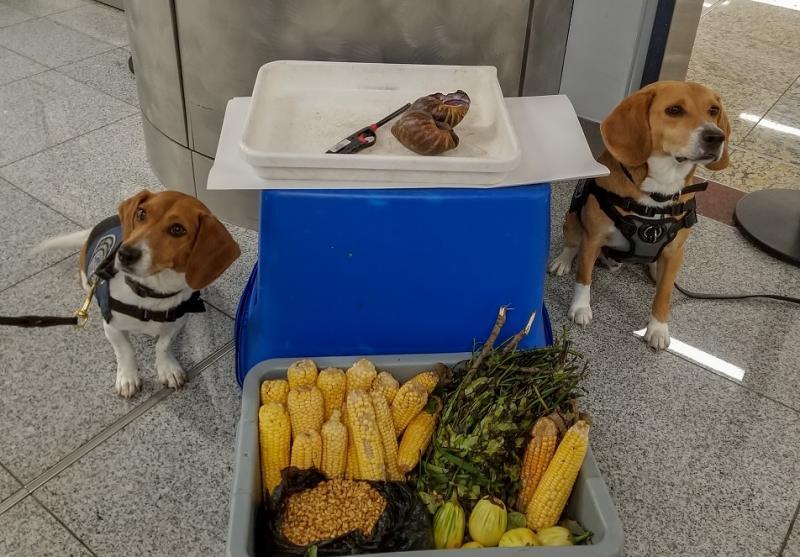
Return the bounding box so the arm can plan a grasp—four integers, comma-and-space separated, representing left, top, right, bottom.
39, 190, 240, 398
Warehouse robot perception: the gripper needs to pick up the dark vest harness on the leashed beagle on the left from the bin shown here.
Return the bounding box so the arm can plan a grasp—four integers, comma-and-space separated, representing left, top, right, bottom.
84, 216, 206, 323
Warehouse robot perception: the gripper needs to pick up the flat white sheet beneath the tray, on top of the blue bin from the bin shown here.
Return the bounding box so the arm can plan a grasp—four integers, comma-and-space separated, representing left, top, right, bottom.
206, 95, 608, 190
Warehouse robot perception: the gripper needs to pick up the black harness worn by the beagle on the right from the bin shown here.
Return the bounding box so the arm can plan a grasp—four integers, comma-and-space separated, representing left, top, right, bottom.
569, 166, 708, 263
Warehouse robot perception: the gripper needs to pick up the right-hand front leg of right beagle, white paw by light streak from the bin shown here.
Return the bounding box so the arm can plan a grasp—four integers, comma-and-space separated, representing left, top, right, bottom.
644, 234, 686, 350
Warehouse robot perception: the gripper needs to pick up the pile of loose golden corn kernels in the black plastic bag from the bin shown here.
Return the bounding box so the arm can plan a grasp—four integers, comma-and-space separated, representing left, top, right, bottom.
281, 480, 386, 546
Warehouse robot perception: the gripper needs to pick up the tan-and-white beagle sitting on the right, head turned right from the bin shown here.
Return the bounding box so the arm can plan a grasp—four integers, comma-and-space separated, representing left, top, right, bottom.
549, 81, 730, 350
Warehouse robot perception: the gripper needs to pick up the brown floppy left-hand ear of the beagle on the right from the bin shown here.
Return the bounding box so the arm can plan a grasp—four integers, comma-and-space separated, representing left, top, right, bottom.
600, 89, 655, 166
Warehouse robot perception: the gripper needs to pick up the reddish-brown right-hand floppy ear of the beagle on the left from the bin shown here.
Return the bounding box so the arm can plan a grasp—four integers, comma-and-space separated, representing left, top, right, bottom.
186, 213, 241, 290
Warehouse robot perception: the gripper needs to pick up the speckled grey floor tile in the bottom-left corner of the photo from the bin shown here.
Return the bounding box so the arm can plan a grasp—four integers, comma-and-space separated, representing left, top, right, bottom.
0, 497, 91, 557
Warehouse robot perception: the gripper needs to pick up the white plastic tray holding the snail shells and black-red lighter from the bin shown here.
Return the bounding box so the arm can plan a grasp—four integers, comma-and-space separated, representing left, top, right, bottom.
241, 60, 521, 185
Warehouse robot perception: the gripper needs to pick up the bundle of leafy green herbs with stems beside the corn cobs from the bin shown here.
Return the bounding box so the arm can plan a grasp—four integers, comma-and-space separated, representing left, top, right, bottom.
416, 308, 587, 513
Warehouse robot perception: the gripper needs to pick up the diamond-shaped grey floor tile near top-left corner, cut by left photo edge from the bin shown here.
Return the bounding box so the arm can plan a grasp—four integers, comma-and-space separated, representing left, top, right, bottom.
0, 18, 114, 68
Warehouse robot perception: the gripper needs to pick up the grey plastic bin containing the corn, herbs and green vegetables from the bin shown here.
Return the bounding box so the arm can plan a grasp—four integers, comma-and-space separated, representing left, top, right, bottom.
227, 354, 623, 557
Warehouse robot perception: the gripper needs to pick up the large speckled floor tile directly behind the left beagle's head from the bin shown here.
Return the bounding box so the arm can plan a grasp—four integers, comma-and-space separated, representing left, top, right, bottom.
0, 114, 161, 228
